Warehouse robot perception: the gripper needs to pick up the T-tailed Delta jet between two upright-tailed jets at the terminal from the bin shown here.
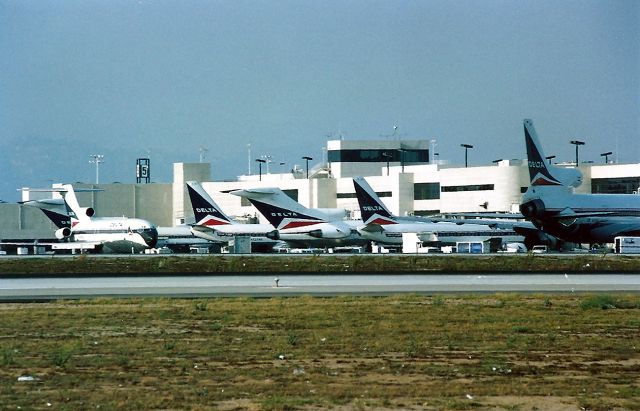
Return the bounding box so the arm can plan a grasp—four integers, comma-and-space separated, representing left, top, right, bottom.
229, 187, 370, 247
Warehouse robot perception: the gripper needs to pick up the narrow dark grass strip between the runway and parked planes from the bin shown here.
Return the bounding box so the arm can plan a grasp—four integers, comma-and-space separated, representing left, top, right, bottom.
0, 254, 640, 278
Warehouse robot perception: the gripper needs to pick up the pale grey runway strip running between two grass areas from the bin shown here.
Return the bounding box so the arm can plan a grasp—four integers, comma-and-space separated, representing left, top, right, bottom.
0, 274, 640, 301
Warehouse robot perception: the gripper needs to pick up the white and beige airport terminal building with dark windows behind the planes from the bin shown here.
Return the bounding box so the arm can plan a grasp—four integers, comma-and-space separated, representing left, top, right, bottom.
0, 140, 640, 241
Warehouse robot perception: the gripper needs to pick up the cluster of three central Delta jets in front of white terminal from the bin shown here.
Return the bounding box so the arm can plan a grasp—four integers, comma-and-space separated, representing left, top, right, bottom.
187, 177, 523, 253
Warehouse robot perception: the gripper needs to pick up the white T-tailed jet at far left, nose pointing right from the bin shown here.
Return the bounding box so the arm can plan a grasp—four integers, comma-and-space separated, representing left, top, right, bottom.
19, 184, 158, 253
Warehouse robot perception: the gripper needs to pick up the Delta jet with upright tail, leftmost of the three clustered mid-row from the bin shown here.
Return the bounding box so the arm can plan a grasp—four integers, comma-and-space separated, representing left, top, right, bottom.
187, 181, 279, 251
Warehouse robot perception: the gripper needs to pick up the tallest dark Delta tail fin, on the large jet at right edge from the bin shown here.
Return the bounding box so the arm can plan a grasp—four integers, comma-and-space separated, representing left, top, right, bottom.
524, 119, 582, 187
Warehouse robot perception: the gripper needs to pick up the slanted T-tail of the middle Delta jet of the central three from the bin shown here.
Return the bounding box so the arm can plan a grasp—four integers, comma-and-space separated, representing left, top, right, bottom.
230, 188, 327, 230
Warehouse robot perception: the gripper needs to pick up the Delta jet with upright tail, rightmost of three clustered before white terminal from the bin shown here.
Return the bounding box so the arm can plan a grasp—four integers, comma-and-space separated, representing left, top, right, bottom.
353, 177, 523, 249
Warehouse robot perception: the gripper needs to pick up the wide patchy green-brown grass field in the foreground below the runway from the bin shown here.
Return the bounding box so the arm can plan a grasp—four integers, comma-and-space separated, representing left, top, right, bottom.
0, 294, 640, 410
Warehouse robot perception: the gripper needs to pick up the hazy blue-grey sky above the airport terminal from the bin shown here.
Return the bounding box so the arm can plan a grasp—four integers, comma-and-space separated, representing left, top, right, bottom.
0, 0, 640, 201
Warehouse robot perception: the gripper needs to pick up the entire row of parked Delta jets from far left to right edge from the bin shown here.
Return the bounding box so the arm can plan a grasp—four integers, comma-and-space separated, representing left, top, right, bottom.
7, 120, 640, 253
